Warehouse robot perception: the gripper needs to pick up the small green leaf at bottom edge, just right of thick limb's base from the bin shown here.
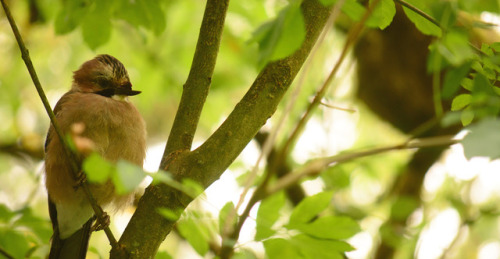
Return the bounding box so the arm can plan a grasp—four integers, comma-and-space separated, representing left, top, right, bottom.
177, 217, 209, 256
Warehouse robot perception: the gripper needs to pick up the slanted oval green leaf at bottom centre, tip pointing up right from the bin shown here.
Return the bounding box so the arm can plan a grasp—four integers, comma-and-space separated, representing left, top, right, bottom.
288, 191, 333, 226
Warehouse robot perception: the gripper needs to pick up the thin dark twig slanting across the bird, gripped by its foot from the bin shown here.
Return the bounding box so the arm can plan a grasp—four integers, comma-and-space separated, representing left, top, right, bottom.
1, 0, 117, 247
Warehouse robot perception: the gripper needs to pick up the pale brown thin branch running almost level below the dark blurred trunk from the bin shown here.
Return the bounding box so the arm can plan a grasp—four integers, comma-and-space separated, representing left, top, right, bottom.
266, 136, 460, 195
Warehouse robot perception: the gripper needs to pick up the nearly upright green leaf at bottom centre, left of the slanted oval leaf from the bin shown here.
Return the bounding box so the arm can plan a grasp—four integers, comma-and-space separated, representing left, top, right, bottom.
255, 192, 285, 241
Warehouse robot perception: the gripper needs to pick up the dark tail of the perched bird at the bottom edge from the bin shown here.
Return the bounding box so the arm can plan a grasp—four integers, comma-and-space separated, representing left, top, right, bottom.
49, 218, 94, 259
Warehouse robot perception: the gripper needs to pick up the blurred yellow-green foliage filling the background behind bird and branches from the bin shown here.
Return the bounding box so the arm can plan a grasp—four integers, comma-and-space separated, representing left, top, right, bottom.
0, 0, 500, 258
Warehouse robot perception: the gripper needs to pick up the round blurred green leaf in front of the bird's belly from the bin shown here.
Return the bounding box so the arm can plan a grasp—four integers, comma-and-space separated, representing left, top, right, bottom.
82, 152, 116, 183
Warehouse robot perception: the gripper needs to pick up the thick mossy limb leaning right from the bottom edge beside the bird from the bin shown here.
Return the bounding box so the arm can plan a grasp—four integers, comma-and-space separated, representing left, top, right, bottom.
111, 0, 329, 258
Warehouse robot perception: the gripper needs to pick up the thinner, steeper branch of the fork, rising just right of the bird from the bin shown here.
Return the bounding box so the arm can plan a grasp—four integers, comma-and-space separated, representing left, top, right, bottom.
160, 0, 229, 169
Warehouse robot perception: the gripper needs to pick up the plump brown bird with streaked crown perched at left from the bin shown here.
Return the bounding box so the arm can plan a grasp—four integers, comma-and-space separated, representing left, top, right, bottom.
45, 54, 146, 259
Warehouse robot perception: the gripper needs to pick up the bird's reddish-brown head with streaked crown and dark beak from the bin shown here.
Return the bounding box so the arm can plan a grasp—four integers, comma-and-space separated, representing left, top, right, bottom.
72, 55, 141, 97
